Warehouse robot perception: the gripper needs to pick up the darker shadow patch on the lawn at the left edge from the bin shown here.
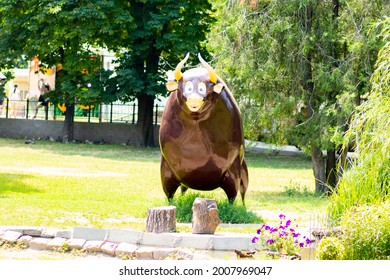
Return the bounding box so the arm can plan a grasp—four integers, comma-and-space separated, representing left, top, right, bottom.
0, 173, 42, 199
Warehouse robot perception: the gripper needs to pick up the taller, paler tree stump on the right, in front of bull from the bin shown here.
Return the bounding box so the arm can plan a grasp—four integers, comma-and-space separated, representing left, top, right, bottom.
192, 197, 221, 234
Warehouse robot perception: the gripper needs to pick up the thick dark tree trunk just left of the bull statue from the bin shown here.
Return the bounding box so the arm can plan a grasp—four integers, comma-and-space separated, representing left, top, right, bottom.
137, 95, 154, 147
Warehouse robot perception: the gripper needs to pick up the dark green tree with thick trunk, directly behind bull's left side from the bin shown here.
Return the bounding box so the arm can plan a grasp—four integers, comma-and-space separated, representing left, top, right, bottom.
109, 0, 213, 146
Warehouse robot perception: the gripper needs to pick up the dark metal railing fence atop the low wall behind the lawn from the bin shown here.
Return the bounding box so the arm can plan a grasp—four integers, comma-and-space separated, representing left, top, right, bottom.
0, 98, 164, 125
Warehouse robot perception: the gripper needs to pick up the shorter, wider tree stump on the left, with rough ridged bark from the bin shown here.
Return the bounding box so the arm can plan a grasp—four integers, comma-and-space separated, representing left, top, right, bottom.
146, 206, 176, 233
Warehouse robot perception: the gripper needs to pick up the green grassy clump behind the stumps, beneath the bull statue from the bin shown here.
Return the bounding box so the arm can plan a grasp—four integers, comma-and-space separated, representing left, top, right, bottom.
172, 193, 262, 224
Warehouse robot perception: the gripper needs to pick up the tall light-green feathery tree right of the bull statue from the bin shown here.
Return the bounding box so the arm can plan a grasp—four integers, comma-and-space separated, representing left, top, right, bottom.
211, 0, 389, 193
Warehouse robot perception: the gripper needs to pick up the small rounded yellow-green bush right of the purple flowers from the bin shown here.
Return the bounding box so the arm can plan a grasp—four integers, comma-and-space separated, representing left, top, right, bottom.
316, 236, 344, 260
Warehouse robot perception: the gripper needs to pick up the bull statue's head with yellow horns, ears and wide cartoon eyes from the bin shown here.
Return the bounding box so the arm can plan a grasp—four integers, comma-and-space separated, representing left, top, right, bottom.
167, 53, 223, 112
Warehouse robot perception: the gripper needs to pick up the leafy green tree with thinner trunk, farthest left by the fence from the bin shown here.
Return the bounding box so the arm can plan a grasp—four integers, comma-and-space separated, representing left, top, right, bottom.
0, 0, 132, 140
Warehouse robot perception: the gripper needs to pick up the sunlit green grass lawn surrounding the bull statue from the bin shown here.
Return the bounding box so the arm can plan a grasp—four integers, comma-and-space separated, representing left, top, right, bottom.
0, 139, 328, 230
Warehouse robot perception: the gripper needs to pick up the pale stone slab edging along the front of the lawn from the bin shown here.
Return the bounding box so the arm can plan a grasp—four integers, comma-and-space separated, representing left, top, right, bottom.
0, 227, 254, 260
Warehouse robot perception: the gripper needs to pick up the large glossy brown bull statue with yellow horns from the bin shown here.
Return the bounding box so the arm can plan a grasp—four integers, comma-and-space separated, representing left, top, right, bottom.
159, 53, 248, 204
